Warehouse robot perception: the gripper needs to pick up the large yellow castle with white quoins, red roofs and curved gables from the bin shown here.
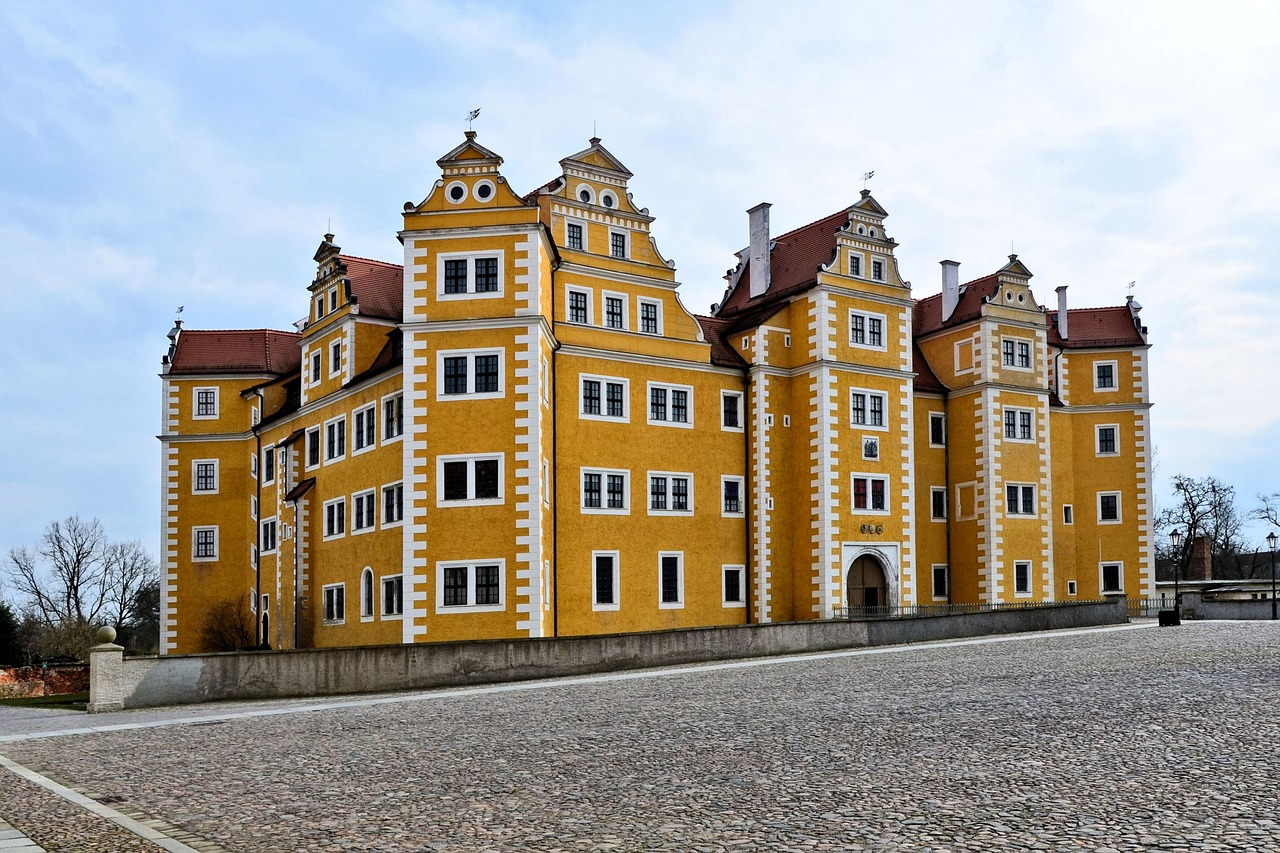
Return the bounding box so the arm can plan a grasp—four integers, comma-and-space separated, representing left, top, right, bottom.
160, 132, 1155, 653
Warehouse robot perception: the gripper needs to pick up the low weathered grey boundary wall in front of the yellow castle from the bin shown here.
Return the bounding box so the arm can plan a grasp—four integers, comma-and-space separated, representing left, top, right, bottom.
97, 598, 1129, 711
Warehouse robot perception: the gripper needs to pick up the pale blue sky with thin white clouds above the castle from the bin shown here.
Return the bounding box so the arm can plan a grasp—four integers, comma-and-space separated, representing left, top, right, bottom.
0, 0, 1280, 563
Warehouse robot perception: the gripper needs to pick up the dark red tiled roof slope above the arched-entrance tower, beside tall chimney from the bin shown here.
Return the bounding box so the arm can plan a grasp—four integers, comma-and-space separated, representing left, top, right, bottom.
718, 207, 851, 320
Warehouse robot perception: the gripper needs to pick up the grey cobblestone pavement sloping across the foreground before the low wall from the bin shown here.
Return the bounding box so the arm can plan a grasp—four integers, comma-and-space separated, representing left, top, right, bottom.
0, 622, 1280, 853
